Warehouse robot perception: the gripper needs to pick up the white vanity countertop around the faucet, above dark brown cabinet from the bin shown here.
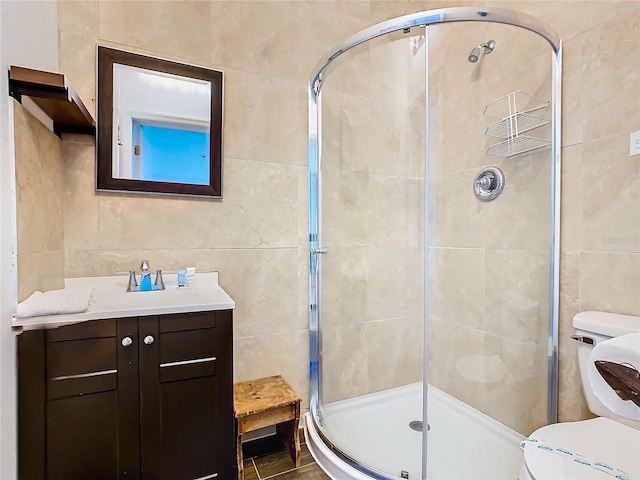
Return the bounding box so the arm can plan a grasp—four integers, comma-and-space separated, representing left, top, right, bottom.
11, 272, 236, 330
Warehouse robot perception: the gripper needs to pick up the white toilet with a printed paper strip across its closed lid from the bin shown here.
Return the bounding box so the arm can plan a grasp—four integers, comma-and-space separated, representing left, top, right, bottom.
519, 312, 640, 480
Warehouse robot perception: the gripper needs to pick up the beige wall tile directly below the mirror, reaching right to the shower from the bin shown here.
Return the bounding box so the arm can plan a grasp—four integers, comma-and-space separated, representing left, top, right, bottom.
99, 159, 298, 249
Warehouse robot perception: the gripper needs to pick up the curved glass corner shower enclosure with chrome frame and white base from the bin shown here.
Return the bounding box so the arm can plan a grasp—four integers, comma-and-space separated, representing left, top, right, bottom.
305, 7, 561, 480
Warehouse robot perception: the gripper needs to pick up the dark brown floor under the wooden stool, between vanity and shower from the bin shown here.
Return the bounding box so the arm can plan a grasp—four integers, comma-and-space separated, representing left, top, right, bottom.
244, 444, 329, 480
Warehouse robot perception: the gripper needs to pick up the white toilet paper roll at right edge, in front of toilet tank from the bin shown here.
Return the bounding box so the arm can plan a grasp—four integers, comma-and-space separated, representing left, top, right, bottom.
587, 333, 640, 422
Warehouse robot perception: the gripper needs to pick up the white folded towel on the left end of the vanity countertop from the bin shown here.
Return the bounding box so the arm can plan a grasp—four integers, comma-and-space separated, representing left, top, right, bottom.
16, 287, 93, 318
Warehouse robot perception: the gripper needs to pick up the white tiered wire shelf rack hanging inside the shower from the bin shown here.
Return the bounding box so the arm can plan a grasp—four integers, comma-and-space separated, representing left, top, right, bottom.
484, 90, 551, 157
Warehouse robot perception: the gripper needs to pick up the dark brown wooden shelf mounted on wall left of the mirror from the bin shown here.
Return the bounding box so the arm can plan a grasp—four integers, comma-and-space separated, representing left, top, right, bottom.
9, 65, 96, 137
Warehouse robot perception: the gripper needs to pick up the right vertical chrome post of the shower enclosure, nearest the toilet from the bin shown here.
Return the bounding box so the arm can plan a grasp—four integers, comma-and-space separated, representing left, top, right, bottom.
547, 41, 562, 423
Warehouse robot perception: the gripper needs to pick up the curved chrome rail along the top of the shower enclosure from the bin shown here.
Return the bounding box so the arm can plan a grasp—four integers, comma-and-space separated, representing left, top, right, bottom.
309, 7, 560, 95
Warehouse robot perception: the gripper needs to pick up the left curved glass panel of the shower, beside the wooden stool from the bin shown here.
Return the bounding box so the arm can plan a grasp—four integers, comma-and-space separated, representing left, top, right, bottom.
316, 28, 426, 478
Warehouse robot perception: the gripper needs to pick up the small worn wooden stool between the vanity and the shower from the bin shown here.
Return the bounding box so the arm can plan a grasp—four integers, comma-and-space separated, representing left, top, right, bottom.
233, 375, 300, 480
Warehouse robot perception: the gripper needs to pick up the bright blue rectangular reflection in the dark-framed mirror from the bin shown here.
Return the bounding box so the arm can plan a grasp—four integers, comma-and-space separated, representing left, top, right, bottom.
132, 119, 210, 185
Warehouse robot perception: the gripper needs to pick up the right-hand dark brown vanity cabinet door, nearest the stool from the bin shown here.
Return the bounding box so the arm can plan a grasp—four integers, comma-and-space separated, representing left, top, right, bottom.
139, 311, 235, 480
